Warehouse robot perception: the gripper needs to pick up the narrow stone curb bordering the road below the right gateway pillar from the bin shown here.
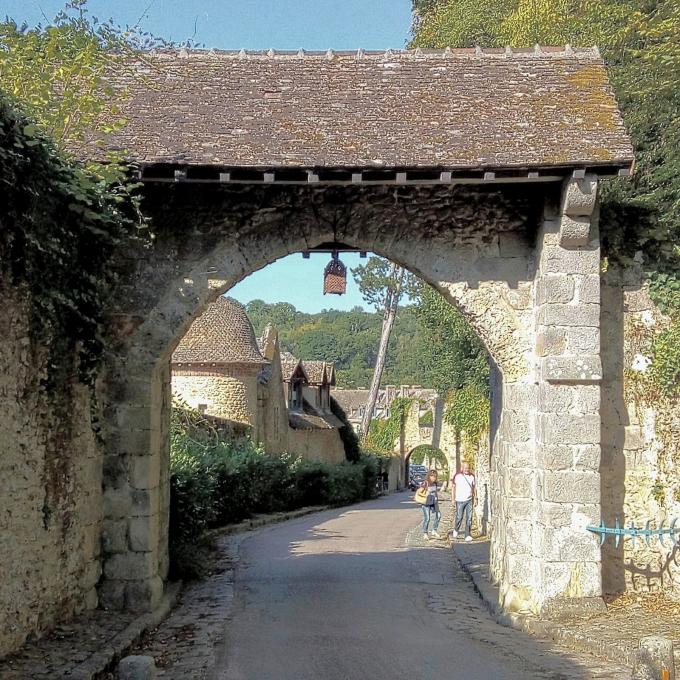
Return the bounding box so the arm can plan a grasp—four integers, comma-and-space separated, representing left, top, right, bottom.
451, 541, 637, 668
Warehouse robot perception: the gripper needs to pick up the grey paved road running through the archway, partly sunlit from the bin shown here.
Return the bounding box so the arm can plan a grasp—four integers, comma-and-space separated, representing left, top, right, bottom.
213, 494, 630, 680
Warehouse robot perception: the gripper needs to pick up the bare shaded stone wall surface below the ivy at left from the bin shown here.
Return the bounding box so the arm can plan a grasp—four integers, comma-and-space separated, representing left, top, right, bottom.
0, 291, 102, 656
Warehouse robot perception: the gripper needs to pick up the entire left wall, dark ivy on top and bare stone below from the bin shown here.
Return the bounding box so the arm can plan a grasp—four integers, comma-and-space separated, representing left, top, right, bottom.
0, 96, 140, 656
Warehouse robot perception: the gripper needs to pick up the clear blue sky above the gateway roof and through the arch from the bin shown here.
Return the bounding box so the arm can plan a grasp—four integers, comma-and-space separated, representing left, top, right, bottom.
5, 0, 411, 312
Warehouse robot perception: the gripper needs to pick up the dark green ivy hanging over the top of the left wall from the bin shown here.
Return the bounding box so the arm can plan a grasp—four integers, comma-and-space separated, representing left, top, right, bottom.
0, 91, 142, 391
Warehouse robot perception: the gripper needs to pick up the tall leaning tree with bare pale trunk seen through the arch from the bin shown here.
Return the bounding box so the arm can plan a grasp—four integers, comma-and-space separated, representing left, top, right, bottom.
352, 257, 412, 441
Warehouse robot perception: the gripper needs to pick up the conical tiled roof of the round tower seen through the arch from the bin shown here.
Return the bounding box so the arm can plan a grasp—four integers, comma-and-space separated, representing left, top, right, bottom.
172, 297, 265, 364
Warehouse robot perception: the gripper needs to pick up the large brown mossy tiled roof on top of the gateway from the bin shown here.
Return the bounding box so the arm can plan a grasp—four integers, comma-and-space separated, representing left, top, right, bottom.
93, 47, 633, 170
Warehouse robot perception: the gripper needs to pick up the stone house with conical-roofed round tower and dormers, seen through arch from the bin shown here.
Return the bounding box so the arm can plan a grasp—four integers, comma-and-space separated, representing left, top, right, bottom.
172, 297, 345, 463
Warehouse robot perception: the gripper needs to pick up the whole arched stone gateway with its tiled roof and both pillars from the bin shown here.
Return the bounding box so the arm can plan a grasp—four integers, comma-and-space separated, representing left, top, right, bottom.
0, 47, 644, 656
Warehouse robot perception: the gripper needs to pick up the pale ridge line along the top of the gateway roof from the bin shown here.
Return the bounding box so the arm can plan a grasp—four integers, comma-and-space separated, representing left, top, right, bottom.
155, 45, 601, 61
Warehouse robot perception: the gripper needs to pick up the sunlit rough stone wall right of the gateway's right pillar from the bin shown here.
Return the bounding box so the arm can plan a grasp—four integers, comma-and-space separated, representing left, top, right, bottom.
602, 267, 680, 598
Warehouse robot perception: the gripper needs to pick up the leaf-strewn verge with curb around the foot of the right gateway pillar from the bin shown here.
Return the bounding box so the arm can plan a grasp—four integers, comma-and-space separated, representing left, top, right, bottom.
452, 541, 680, 667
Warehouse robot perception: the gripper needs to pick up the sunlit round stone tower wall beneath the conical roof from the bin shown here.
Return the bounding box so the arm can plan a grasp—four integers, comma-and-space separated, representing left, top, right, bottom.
172, 365, 259, 430
